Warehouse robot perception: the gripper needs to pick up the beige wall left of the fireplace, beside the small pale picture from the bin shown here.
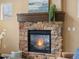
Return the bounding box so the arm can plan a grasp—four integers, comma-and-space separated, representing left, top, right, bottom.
2, 0, 28, 52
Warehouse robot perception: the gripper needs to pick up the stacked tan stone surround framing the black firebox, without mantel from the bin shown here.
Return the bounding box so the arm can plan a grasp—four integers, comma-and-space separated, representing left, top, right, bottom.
19, 22, 63, 53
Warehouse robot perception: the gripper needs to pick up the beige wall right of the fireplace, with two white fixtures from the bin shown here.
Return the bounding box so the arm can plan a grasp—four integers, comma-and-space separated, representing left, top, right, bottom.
63, 0, 79, 52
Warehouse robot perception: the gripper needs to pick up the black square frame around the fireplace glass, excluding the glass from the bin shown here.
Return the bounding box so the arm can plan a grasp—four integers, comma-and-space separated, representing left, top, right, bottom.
28, 30, 51, 53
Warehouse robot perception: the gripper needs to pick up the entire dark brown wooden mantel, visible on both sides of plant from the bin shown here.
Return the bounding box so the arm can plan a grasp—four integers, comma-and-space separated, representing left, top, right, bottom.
17, 11, 65, 22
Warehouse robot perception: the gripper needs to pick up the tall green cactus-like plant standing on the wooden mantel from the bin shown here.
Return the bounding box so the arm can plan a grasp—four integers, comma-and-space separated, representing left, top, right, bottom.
49, 4, 57, 21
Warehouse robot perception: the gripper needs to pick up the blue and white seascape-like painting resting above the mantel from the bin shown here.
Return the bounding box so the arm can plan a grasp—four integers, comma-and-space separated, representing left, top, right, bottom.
28, 0, 50, 13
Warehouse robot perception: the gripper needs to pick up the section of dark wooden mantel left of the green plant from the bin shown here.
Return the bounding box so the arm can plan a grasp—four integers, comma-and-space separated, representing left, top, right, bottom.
17, 13, 48, 22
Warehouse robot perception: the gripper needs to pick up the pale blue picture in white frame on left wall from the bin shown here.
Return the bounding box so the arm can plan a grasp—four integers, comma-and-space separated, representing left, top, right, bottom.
0, 3, 13, 20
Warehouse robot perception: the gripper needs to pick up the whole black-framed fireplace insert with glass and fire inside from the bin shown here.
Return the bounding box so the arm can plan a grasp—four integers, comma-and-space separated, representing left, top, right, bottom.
28, 30, 51, 53
